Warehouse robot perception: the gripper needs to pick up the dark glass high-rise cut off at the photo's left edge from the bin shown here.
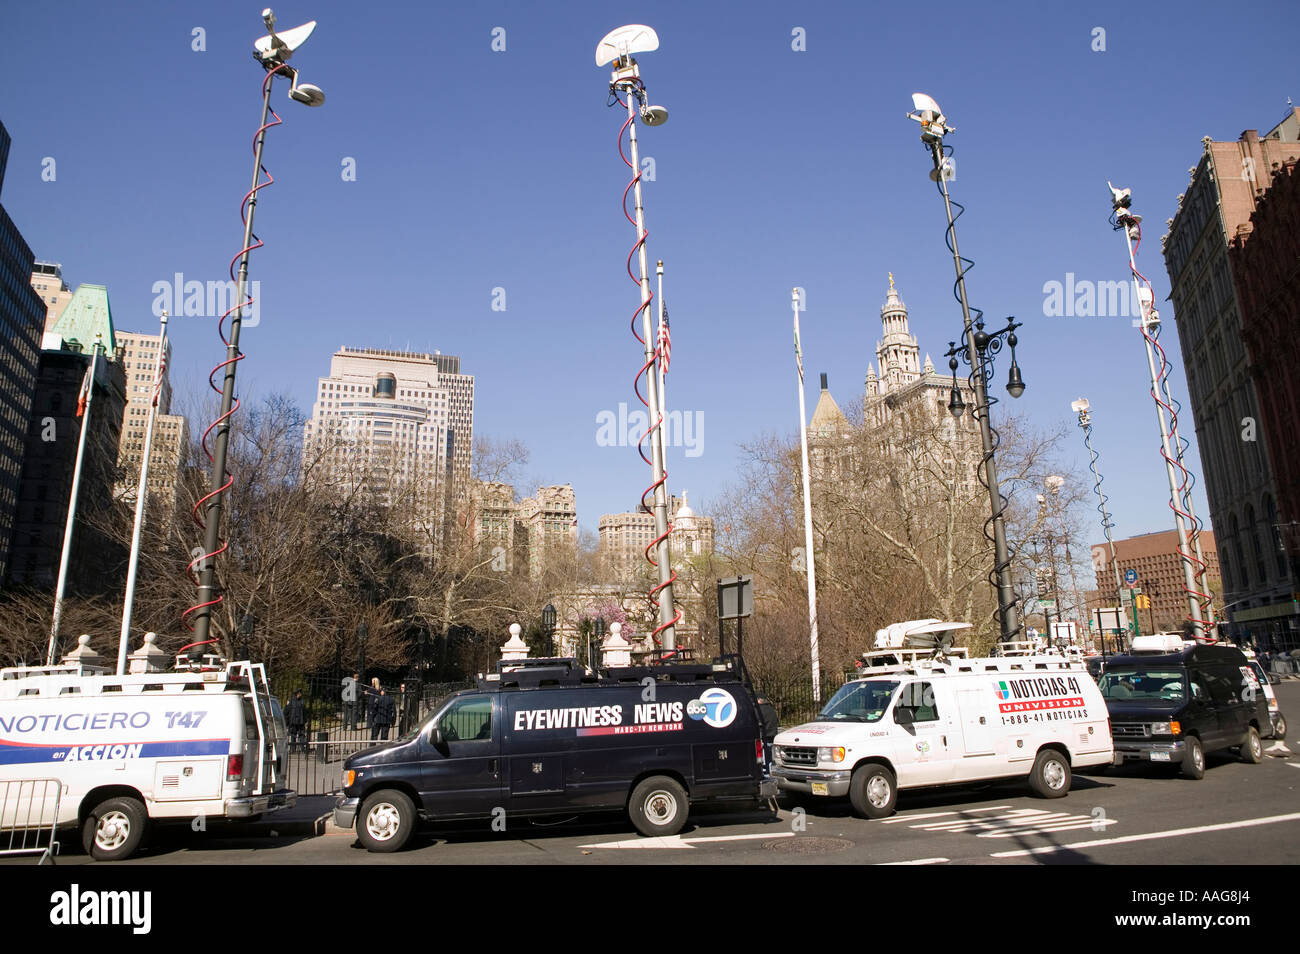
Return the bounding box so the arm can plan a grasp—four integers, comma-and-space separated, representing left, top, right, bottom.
0, 123, 46, 580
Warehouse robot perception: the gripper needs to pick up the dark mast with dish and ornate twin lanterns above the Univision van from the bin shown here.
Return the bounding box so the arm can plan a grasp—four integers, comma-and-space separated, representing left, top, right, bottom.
907, 92, 1024, 643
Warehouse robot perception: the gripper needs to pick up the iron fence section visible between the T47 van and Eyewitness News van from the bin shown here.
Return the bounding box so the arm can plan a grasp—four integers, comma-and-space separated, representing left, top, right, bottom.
272, 672, 475, 795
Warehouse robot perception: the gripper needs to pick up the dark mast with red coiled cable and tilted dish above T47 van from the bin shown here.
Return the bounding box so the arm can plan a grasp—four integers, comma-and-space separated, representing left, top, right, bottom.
185, 6, 325, 667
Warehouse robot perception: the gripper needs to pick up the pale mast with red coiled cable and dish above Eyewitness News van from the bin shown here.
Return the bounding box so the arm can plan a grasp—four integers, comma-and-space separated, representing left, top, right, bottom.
595, 23, 681, 650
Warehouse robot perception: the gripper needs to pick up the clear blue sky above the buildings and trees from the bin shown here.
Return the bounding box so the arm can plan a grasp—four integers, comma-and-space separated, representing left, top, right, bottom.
0, 0, 1300, 545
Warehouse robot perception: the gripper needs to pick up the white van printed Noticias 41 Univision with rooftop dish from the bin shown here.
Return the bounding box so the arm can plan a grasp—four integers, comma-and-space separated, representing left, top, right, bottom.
772, 620, 1114, 818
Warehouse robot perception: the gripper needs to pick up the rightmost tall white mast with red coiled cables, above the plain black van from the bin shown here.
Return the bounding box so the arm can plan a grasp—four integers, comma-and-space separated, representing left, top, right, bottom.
1106, 182, 1214, 639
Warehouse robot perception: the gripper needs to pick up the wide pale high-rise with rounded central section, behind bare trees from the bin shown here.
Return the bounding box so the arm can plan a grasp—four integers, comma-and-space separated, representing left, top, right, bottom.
304, 347, 475, 515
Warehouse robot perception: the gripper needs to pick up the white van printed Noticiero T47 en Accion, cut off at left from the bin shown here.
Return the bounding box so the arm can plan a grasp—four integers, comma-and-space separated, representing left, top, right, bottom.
0, 662, 298, 860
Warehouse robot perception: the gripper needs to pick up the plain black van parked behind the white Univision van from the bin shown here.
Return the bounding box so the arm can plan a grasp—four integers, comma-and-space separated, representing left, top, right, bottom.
1099, 643, 1270, 779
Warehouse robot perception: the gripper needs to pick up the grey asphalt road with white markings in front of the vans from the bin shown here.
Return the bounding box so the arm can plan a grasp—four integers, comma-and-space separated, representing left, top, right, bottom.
20, 681, 1300, 868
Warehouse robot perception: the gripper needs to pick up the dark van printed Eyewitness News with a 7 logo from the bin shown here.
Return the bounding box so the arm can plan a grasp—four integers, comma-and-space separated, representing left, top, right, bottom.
334, 659, 776, 851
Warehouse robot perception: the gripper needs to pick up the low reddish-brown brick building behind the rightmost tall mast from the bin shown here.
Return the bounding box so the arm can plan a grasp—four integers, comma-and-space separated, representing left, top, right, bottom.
1089, 530, 1219, 633
